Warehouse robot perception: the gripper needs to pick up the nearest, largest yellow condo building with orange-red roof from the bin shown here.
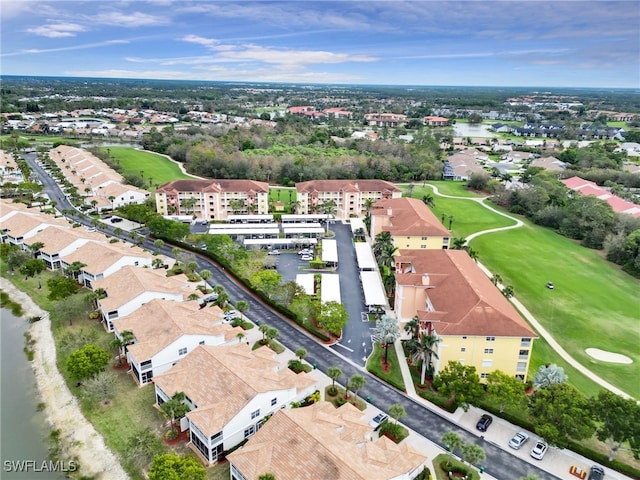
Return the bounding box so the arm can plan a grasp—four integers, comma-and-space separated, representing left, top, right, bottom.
395, 250, 537, 381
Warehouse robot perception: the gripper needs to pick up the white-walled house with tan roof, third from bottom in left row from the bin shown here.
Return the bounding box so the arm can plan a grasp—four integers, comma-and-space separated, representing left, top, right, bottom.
112, 298, 243, 385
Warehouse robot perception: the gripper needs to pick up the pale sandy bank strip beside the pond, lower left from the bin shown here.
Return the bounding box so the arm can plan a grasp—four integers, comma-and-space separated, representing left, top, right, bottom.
0, 278, 129, 480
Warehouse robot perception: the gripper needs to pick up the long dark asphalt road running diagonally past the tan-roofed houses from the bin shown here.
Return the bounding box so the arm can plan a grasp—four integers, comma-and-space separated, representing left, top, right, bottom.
26, 155, 560, 480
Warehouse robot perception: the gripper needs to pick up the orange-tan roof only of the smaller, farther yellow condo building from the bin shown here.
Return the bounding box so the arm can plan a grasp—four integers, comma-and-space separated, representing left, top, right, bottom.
371, 197, 451, 237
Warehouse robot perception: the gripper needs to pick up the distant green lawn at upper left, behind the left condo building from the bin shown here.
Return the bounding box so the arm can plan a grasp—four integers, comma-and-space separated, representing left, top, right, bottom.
102, 147, 196, 189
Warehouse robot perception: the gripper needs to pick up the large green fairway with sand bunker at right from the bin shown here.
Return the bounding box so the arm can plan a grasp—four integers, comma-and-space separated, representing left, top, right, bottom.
471, 222, 640, 398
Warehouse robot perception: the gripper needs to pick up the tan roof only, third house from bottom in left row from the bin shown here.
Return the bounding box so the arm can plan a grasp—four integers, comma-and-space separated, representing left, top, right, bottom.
113, 299, 242, 362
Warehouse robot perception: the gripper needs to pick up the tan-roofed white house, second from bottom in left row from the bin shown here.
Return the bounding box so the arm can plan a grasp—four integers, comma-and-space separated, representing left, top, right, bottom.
154, 343, 317, 466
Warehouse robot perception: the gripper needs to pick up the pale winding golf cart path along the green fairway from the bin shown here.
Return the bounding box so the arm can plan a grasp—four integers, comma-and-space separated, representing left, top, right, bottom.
427, 184, 633, 398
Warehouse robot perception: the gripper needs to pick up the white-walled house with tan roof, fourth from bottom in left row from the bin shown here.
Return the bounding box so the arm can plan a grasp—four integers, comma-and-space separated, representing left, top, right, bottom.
92, 266, 202, 332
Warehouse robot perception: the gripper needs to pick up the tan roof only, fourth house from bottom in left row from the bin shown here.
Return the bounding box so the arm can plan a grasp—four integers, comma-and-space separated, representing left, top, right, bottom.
92, 266, 199, 312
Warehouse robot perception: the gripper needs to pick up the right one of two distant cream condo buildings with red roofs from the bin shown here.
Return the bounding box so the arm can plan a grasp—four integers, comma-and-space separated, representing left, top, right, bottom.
296, 180, 402, 220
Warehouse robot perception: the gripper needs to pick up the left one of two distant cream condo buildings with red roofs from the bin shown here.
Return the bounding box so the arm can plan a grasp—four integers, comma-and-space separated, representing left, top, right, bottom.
156, 179, 269, 220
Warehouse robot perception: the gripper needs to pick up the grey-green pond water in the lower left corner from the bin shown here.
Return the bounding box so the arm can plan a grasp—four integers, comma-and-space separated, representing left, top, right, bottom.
0, 308, 65, 480
